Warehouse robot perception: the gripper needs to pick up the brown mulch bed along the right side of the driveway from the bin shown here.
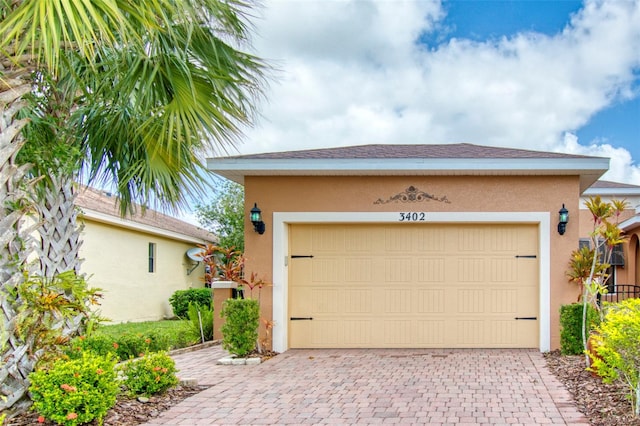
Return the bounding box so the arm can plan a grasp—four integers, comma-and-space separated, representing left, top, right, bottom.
544, 351, 640, 426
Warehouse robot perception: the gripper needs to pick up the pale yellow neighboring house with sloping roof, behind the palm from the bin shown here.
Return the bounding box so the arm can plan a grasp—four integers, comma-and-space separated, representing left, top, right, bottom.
76, 188, 214, 322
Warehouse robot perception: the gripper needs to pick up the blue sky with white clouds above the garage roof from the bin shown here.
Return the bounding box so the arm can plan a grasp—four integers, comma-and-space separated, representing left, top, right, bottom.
221, 0, 640, 185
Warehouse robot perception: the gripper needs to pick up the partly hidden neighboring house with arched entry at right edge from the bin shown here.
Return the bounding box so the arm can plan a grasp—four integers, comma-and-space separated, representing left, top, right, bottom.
580, 181, 640, 300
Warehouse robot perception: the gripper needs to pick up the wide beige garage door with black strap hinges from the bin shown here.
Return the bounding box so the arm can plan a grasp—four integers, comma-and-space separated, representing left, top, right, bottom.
288, 224, 539, 348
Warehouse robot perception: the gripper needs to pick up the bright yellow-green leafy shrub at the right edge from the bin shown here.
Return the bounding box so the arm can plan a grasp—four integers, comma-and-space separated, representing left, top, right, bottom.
591, 299, 640, 416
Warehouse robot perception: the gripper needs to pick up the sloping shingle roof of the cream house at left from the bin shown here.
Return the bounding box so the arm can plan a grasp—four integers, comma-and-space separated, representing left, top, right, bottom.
76, 186, 216, 242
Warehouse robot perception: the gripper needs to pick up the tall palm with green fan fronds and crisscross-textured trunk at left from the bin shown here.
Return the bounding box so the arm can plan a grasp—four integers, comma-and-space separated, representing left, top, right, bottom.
0, 0, 268, 407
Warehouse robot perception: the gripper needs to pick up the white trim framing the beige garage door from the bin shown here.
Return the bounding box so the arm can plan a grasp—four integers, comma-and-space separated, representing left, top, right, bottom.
272, 212, 551, 352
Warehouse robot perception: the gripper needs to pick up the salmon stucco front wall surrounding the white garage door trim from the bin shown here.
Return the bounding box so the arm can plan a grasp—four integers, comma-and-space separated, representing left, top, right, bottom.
245, 176, 580, 349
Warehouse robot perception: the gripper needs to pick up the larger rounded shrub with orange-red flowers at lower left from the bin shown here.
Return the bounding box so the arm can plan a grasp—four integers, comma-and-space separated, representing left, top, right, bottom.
29, 353, 119, 425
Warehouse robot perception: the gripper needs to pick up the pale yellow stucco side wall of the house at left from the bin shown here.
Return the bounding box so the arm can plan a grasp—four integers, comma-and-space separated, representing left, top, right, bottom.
80, 219, 204, 323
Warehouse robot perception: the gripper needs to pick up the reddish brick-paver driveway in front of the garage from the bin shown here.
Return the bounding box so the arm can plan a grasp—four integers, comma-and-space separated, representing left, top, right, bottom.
148, 346, 588, 425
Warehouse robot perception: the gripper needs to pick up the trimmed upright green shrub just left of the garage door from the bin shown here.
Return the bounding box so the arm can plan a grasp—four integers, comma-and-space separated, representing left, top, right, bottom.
220, 299, 260, 357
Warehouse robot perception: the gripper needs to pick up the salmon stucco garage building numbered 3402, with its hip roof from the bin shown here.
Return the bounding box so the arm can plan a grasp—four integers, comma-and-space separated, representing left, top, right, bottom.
208, 144, 609, 351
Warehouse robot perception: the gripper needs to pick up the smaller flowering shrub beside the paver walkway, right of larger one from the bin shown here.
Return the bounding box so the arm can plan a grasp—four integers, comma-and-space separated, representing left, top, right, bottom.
119, 352, 178, 396
